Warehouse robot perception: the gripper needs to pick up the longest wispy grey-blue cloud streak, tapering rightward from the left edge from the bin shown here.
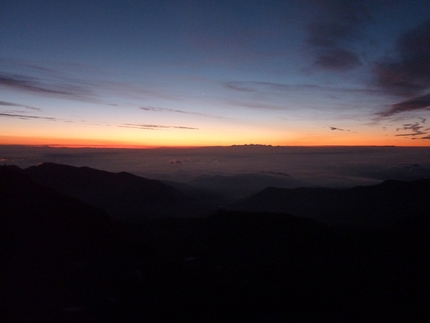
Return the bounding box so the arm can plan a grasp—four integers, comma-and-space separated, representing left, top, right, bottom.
0, 58, 178, 105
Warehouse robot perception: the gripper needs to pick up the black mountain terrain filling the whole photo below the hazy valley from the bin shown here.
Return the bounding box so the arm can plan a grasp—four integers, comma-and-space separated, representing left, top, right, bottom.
0, 166, 430, 322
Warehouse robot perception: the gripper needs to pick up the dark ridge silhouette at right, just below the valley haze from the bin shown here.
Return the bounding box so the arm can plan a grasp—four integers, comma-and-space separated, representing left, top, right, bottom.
229, 179, 430, 225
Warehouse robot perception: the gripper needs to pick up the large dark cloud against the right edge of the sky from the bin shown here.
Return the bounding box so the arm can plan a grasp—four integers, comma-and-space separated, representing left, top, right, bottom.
374, 20, 430, 98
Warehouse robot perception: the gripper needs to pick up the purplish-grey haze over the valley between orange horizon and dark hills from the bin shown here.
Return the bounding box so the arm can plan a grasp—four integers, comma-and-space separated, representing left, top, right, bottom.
0, 145, 430, 196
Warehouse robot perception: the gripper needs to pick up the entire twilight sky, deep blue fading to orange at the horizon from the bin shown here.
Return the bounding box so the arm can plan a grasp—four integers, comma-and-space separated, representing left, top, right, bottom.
0, 0, 430, 147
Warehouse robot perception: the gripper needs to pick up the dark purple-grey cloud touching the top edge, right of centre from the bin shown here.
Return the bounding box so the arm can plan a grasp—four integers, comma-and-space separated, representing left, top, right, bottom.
306, 0, 371, 71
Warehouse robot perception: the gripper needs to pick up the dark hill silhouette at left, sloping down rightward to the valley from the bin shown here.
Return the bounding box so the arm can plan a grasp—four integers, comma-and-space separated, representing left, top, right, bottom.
24, 163, 218, 221
